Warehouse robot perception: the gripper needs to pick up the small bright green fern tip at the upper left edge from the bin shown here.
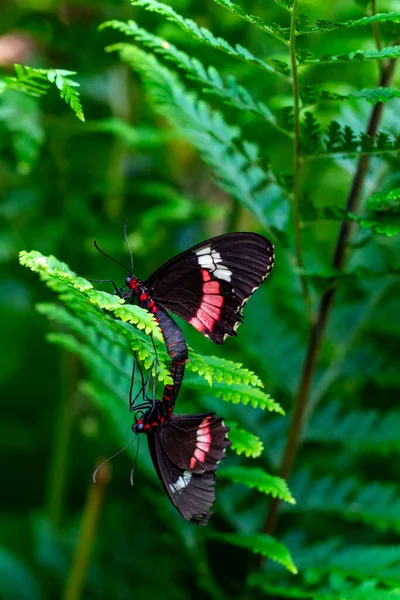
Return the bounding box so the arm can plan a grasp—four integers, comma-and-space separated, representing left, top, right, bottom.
2, 65, 85, 121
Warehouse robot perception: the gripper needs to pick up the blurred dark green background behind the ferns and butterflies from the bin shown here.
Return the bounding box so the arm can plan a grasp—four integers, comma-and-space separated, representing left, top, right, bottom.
0, 0, 400, 600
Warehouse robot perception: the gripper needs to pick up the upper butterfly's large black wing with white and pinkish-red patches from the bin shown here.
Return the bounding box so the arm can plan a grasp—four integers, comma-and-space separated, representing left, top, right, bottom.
145, 233, 274, 344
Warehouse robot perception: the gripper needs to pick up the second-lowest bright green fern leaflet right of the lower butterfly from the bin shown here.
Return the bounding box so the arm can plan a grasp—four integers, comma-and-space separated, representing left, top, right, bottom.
218, 466, 296, 504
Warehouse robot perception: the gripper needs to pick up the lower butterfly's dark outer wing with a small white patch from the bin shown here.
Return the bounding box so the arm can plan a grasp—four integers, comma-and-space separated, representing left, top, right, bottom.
147, 427, 215, 525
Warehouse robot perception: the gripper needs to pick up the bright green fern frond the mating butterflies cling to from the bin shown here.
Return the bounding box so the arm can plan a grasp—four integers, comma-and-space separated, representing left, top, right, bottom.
20, 252, 283, 413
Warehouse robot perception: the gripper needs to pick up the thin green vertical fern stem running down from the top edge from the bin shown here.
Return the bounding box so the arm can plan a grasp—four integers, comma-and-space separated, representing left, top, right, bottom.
289, 0, 312, 323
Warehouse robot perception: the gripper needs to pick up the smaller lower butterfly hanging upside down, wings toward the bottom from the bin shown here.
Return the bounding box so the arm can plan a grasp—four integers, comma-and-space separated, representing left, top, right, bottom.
132, 400, 231, 525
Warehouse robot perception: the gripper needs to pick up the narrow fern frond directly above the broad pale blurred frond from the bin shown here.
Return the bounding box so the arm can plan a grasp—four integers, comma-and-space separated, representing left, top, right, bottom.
101, 21, 290, 135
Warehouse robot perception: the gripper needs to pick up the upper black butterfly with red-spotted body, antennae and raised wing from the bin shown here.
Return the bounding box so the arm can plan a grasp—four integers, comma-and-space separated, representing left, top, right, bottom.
95, 230, 274, 404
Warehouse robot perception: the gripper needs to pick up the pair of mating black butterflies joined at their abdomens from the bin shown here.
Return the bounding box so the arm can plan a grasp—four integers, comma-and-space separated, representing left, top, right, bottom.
100, 233, 274, 525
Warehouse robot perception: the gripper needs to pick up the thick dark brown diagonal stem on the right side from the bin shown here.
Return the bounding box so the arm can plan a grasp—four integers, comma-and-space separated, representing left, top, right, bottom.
264, 54, 396, 534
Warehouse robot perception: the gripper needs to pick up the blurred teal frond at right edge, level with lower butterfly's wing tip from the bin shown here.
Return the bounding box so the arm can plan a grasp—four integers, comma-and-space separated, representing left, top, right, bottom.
290, 471, 400, 533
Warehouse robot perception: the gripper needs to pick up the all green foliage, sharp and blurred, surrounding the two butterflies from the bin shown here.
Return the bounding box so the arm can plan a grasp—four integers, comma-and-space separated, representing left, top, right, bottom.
0, 0, 400, 600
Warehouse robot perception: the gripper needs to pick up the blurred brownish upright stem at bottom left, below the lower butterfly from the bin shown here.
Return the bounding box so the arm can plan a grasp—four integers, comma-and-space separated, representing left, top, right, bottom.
63, 461, 111, 600
